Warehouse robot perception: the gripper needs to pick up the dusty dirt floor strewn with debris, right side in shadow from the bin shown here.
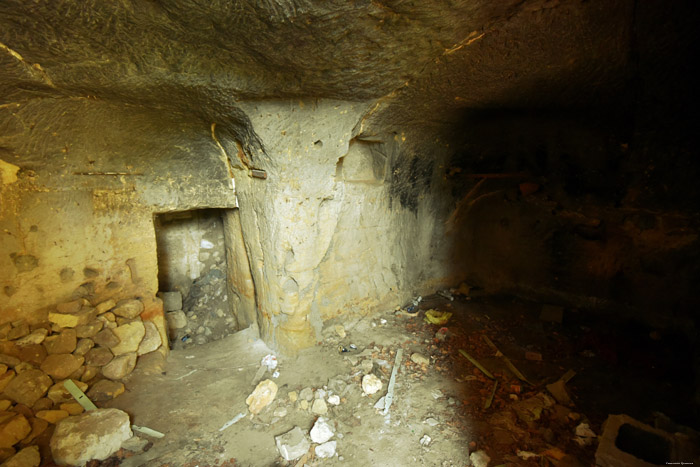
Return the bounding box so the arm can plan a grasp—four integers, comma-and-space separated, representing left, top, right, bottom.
90, 290, 692, 467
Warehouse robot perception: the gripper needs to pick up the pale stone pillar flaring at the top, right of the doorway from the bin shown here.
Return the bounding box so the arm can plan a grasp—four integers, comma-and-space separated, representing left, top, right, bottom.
231, 100, 366, 353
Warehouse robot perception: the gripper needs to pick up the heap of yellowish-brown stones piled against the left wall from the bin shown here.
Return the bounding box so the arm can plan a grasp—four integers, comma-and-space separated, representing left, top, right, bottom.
0, 298, 165, 466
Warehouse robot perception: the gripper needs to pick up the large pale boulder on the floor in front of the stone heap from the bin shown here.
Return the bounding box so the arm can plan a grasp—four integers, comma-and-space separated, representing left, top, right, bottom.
50, 409, 132, 465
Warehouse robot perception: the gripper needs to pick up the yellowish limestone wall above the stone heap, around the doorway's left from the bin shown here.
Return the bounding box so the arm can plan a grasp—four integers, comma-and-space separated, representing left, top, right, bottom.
0, 99, 235, 330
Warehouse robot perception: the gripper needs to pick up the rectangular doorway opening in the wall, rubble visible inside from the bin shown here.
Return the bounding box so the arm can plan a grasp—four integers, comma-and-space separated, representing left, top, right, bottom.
154, 209, 238, 349
